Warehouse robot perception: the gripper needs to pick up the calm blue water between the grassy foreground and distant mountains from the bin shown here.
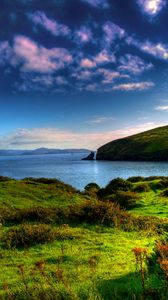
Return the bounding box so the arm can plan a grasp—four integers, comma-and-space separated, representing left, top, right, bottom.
0, 154, 168, 189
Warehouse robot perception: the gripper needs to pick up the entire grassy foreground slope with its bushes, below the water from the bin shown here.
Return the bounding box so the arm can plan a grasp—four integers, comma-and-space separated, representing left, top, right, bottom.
0, 177, 168, 300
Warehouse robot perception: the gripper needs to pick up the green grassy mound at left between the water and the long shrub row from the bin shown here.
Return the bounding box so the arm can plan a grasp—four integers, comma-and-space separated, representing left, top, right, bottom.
0, 180, 84, 208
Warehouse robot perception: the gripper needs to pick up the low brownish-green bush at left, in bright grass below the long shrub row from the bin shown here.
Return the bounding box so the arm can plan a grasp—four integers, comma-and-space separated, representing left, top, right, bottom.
3, 224, 74, 248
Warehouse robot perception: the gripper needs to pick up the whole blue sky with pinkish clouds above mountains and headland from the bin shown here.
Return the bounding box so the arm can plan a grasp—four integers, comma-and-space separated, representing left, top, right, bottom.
0, 0, 168, 150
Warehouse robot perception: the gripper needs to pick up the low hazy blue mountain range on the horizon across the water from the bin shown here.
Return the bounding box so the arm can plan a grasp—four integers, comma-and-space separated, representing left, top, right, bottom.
0, 148, 90, 156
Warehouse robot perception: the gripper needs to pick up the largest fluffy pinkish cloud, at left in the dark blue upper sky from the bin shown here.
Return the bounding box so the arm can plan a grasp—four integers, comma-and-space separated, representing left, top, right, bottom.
11, 36, 72, 73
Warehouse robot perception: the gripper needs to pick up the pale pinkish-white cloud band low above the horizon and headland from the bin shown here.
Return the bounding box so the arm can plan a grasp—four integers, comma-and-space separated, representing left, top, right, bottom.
0, 120, 165, 150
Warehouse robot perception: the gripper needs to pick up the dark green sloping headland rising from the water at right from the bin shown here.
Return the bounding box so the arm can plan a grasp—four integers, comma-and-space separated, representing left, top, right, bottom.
96, 126, 168, 161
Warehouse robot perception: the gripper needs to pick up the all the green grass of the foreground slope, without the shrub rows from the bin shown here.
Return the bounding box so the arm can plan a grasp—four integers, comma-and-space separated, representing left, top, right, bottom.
0, 178, 168, 300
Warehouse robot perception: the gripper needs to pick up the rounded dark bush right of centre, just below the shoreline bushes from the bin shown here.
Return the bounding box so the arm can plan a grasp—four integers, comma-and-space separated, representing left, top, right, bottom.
107, 191, 140, 209
